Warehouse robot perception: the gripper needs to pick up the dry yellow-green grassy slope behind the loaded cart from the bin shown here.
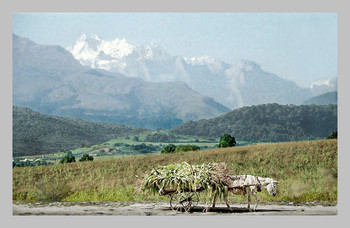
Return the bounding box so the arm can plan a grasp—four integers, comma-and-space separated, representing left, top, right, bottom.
13, 140, 338, 202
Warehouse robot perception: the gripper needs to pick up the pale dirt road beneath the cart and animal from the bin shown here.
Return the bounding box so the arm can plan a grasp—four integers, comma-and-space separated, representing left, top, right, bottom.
12, 202, 338, 216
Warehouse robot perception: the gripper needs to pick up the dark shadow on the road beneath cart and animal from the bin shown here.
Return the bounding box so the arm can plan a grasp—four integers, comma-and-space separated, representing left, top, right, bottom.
164, 206, 296, 213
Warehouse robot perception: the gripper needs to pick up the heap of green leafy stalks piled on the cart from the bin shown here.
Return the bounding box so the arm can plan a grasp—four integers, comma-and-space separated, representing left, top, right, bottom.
141, 162, 231, 200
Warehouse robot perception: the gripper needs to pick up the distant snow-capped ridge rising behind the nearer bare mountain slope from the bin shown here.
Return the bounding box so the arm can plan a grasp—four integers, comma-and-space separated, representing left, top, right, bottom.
66, 35, 334, 109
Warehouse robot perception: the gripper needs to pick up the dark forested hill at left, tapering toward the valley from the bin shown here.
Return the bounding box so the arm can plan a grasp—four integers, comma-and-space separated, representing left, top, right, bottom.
13, 106, 147, 157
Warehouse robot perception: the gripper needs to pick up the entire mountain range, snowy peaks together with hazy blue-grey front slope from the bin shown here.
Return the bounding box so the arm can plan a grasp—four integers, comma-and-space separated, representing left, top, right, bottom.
13, 35, 337, 129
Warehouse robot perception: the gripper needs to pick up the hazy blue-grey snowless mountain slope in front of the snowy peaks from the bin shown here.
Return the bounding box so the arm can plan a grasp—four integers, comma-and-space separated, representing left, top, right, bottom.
13, 35, 229, 128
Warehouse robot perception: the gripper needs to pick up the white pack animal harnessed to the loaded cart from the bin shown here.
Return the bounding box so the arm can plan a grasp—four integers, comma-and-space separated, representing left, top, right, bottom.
212, 175, 278, 211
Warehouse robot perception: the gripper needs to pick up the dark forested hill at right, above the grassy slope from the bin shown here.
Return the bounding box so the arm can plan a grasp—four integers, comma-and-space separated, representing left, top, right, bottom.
171, 104, 337, 142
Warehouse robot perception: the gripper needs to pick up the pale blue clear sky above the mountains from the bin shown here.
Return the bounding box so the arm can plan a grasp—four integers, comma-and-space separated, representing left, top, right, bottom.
13, 13, 338, 87
